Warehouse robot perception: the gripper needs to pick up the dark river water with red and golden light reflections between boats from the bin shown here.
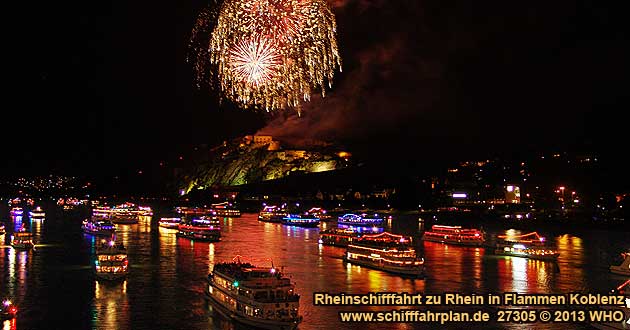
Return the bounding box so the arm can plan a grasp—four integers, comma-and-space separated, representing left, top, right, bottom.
0, 209, 630, 330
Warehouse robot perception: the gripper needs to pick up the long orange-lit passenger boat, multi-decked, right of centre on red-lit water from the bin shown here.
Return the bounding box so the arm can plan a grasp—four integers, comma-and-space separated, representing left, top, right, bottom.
344, 232, 424, 277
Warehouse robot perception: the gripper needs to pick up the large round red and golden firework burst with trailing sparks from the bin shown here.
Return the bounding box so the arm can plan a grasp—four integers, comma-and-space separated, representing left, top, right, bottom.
192, 0, 341, 111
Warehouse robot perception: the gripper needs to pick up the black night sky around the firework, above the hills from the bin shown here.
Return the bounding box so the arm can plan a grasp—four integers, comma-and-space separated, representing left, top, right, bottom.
0, 0, 630, 175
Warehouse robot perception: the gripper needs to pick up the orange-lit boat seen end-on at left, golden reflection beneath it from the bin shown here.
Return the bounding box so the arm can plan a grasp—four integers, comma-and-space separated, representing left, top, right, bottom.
94, 240, 129, 281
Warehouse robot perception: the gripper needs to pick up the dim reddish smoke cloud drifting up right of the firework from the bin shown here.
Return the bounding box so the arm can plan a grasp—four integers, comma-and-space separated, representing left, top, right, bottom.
257, 0, 443, 145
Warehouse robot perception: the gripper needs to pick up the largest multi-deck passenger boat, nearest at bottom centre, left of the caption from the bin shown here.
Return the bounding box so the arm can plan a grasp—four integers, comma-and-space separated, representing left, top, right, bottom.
205, 260, 302, 329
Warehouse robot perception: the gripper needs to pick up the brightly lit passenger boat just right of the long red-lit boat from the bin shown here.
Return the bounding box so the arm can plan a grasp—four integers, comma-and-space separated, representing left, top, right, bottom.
495, 232, 560, 261
